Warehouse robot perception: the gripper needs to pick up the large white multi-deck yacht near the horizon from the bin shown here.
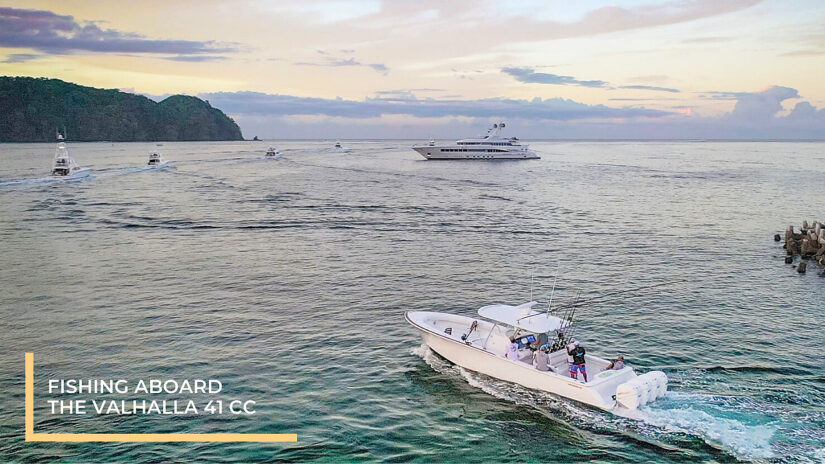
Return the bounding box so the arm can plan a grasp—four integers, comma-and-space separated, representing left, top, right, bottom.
412, 122, 539, 160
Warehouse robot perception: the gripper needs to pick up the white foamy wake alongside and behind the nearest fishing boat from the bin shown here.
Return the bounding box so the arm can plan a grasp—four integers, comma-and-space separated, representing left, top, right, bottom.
412, 345, 779, 460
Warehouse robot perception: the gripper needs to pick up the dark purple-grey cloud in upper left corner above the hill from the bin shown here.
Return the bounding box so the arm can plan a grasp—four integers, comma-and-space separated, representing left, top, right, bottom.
0, 7, 236, 55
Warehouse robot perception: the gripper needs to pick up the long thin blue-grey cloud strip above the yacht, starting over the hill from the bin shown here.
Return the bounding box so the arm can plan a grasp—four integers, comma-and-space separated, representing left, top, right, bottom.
202, 92, 671, 121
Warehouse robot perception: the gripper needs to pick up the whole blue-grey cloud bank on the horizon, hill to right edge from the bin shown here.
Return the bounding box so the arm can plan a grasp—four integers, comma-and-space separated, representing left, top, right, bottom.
200, 86, 825, 140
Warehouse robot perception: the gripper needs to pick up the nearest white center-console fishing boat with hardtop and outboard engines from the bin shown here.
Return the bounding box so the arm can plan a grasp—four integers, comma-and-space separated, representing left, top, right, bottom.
405, 301, 667, 411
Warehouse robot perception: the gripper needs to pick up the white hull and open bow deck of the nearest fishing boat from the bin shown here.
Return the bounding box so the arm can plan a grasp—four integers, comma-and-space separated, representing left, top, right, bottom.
405, 311, 666, 411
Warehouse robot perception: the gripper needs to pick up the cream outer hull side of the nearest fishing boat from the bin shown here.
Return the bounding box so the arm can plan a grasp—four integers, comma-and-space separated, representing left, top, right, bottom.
406, 311, 636, 411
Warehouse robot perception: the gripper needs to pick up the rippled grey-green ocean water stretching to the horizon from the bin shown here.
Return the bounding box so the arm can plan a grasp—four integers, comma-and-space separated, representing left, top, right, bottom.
0, 141, 825, 463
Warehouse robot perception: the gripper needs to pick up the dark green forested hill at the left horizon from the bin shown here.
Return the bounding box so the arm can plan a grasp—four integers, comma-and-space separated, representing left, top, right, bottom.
0, 77, 243, 142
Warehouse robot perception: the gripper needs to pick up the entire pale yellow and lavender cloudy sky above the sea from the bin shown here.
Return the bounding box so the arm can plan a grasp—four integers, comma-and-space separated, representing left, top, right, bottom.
0, 0, 825, 139
